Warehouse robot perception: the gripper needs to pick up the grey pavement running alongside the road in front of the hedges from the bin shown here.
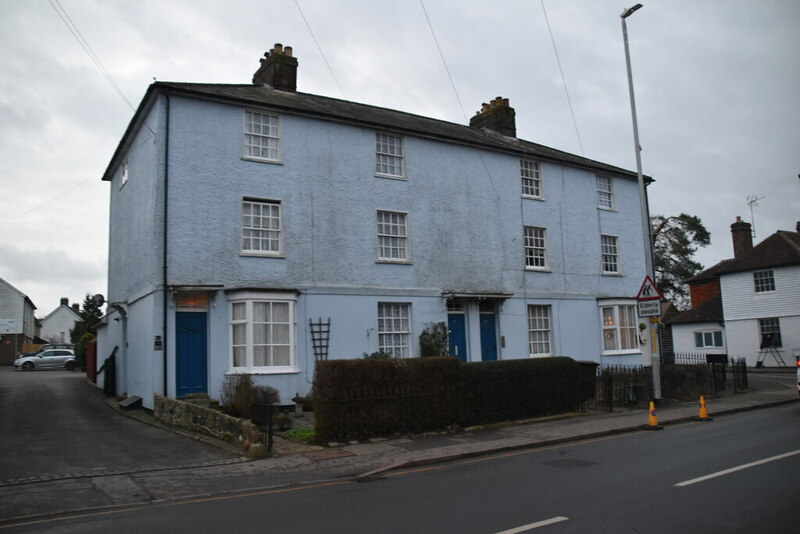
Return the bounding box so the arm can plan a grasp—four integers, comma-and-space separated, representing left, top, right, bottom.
0, 368, 800, 527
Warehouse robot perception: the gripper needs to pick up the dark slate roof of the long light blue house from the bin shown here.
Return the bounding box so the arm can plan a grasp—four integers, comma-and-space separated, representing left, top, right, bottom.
103, 82, 653, 183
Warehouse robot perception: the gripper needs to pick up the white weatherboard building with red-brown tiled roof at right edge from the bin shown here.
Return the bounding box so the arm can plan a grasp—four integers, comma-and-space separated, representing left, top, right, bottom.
669, 217, 800, 366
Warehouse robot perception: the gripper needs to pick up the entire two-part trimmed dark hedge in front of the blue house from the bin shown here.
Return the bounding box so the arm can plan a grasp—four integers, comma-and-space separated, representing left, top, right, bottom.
313, 357, 580, 442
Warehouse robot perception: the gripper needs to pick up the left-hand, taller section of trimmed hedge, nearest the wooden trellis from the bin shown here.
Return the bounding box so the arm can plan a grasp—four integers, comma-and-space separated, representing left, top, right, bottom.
313, 357, 461, 442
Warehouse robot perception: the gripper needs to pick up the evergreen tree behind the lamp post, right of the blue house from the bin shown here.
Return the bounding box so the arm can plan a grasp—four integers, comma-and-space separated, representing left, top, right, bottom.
650, 213, 711, 310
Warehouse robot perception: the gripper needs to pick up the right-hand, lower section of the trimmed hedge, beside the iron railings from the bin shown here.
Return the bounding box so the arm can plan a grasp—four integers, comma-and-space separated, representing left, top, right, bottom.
461, 356, 580, 426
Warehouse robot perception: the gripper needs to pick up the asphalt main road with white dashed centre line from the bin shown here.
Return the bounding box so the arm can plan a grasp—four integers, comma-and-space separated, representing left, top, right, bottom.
9, 405, 800, 534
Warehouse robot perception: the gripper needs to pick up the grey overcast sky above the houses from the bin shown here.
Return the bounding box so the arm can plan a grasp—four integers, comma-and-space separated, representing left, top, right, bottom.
0, 0, 800, 316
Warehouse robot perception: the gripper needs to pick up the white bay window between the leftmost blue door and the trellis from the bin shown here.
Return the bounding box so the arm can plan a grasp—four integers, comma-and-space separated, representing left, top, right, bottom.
228, 291, 299, 374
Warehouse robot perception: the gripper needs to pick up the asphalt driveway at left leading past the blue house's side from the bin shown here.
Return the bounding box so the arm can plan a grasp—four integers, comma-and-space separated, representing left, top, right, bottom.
0, 367, 238, 481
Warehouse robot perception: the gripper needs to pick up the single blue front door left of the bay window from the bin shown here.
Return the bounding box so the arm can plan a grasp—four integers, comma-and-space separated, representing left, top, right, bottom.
175, 312, 208, 398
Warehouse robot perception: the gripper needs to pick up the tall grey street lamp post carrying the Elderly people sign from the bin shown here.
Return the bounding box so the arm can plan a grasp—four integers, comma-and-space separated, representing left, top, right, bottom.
620, 4, 661, 401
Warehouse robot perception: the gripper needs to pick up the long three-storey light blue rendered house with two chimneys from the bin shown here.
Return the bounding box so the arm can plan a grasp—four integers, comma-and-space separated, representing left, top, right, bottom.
98, 45, 651, 408
